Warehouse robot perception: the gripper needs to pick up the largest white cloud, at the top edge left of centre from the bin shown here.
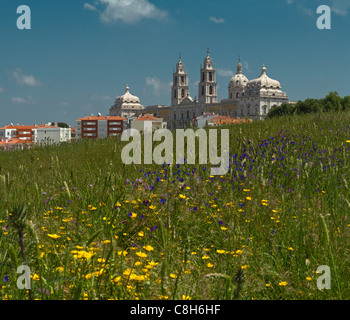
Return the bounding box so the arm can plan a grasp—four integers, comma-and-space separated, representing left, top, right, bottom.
84, 0, 168, 24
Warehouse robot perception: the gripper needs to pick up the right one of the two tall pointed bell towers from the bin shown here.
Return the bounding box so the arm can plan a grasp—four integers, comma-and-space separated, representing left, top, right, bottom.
198, 49, 218, 103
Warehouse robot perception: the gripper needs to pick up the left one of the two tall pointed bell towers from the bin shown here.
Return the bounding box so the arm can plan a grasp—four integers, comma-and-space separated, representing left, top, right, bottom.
171, 54, 189, 106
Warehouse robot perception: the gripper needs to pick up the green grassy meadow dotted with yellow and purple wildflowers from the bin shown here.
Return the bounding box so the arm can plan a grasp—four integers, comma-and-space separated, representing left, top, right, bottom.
0, 113, 350, 300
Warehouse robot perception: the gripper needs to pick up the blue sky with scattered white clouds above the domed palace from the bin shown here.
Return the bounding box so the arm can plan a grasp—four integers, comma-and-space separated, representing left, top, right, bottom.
0, 0, 350, 126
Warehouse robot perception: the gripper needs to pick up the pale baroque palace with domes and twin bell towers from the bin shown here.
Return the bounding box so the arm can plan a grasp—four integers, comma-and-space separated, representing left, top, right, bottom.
110, 50, 288, 129
